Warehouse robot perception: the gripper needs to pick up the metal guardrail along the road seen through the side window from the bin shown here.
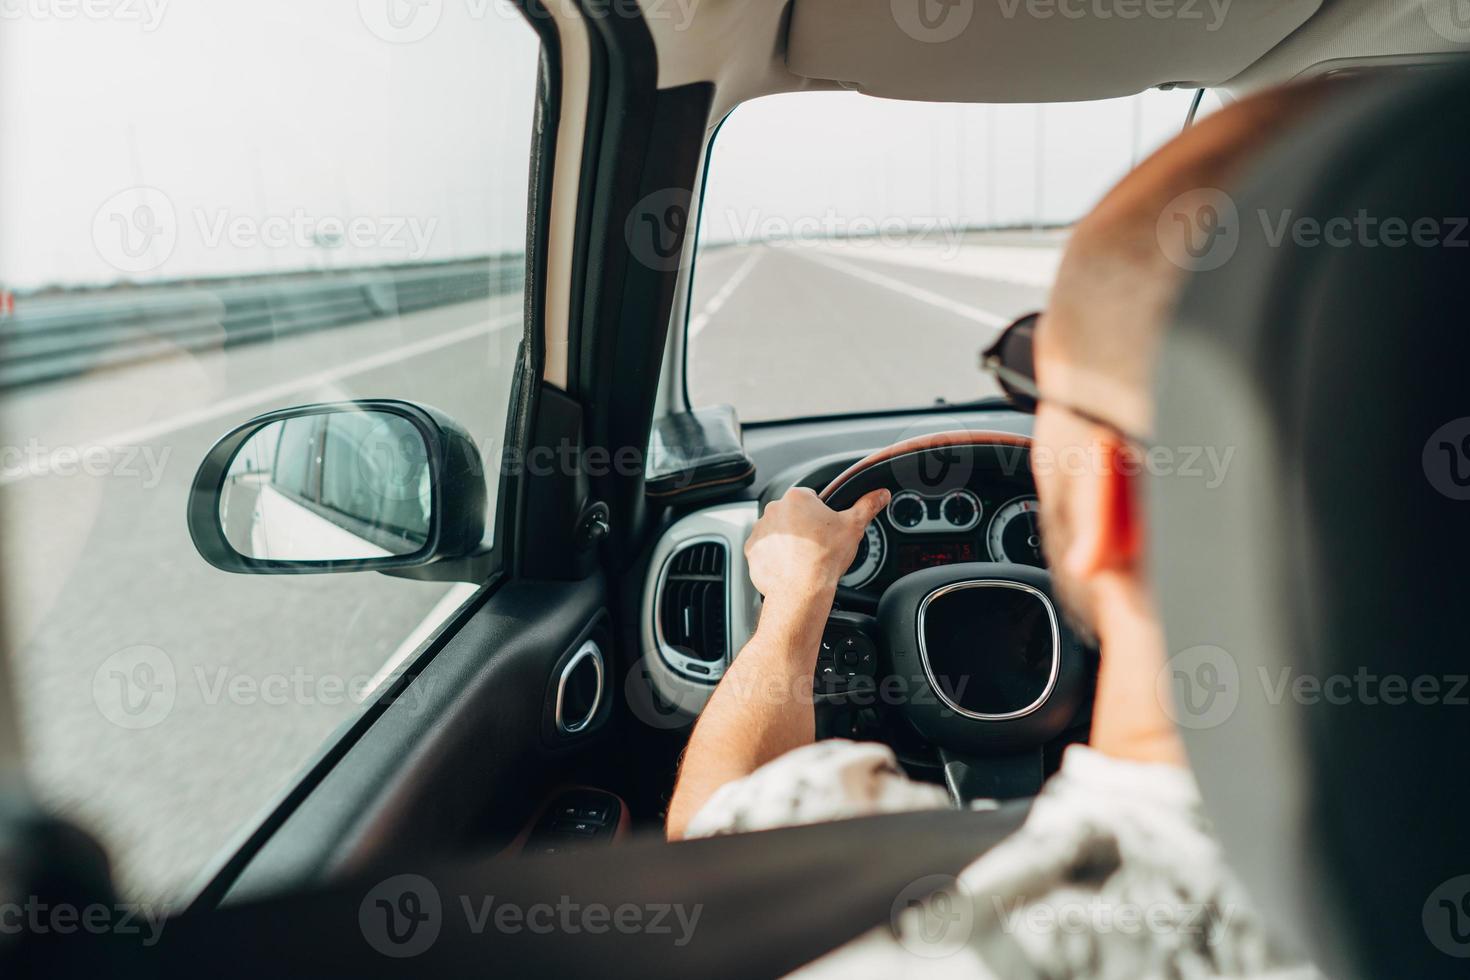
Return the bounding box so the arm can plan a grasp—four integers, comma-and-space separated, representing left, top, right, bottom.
0, 256, 525, 388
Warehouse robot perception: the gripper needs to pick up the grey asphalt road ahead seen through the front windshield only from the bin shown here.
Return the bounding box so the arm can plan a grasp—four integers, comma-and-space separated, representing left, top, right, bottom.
688, 239, 1055, 422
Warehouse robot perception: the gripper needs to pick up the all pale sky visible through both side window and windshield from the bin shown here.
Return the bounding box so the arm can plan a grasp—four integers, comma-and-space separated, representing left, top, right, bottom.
0, 0, 1211, 291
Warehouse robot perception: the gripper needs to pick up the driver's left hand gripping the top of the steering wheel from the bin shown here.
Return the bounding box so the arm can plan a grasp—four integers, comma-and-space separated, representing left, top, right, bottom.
745, 486, 892, 619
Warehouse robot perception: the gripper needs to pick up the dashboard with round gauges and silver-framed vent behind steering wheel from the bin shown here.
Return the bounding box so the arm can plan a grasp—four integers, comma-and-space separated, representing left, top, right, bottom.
639, 411, 1044, 720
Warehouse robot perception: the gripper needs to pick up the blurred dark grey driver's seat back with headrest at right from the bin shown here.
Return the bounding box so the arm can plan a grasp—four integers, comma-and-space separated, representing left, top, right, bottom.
1147, 69, 1470, 977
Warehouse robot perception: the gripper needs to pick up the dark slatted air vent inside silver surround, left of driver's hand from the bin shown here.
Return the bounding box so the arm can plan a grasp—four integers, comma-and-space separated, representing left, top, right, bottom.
656, 541, 729, 669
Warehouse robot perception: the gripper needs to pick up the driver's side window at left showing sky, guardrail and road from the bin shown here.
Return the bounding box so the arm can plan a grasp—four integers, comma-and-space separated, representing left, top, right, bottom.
0, 0, 541, 902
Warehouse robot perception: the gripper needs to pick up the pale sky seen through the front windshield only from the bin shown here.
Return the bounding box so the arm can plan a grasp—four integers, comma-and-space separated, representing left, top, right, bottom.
700, 91, 1211, 241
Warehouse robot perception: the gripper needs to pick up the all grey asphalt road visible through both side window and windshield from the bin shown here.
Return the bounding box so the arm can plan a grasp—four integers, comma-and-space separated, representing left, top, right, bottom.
0, 230, 1054, 896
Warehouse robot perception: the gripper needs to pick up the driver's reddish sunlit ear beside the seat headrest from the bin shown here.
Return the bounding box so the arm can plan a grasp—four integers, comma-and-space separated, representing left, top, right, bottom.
1063, 428, 1144, 580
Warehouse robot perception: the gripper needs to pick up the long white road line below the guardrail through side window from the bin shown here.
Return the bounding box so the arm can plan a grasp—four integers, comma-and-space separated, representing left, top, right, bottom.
0, 313, 523, 486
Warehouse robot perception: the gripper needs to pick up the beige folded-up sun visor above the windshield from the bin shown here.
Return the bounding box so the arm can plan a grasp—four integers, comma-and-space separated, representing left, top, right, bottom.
786, 0, 1322, 103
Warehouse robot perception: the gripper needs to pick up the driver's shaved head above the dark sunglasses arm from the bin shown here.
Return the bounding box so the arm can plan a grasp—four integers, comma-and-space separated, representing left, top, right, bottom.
1036, 82, 1341, 433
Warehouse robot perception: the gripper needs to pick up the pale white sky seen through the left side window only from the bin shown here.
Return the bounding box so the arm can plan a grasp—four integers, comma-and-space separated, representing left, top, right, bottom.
0, 0, 539, 288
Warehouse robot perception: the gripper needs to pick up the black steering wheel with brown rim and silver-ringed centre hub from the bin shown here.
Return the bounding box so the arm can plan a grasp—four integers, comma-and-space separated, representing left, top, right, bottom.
817, 430, 1089, 799
